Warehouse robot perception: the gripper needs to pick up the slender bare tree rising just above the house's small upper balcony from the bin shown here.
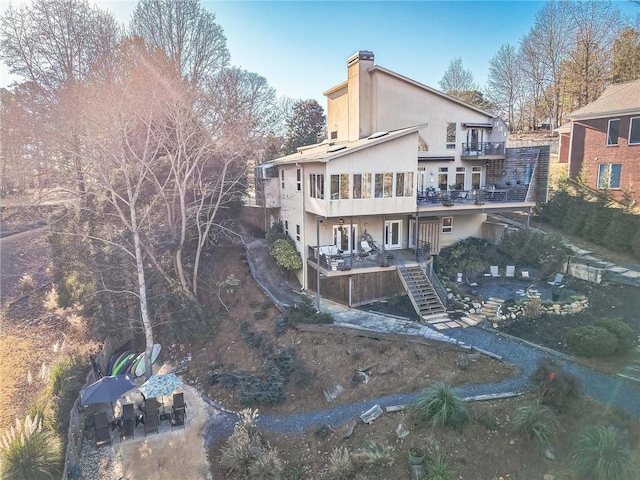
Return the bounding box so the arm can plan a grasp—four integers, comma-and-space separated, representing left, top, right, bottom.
487, 43, 522, 131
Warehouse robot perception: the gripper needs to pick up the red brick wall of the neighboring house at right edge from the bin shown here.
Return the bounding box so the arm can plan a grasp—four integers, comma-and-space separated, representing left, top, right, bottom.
569, 116, 640, 197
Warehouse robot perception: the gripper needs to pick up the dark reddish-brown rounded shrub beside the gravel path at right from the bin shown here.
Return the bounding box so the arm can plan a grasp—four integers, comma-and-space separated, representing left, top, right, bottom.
530, 358, 581, 411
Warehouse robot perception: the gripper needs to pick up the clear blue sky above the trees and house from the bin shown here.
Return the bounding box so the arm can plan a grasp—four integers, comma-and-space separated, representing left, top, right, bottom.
0, 0, 640, 107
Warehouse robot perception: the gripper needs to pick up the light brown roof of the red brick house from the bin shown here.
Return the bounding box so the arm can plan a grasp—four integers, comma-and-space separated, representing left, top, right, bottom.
568, 80, 640, 120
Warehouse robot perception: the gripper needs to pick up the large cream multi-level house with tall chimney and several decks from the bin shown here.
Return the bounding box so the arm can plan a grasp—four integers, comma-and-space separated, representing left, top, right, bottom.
256, 51, 548, 314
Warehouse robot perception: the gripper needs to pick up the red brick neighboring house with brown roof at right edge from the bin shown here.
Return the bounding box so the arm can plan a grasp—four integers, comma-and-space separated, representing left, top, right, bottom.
557, 80, 640, 200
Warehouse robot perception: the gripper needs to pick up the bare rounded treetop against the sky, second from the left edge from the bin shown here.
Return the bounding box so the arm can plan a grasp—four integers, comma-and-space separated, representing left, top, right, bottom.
130, 0, 229, 85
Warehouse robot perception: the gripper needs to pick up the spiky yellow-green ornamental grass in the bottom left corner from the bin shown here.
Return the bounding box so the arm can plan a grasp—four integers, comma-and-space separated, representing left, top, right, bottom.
0, 416, 63, 479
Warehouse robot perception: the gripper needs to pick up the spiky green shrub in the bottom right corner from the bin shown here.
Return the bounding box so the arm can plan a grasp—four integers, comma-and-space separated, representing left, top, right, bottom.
571, 425, 632, 480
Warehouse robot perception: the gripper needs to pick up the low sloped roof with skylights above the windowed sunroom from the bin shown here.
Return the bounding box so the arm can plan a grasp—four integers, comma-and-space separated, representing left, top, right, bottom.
269, 124, 426, 166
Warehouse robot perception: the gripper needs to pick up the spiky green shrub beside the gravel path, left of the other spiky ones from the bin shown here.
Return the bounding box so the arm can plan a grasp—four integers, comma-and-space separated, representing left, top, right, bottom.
415, 382, 469, 428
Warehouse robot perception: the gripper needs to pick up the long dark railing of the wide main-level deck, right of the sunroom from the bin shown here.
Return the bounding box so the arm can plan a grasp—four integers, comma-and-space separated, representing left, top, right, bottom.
417, 186, 528, 207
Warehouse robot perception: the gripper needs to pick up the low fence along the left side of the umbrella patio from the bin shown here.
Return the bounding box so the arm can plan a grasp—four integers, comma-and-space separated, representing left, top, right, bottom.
62, 337, 114, 480
